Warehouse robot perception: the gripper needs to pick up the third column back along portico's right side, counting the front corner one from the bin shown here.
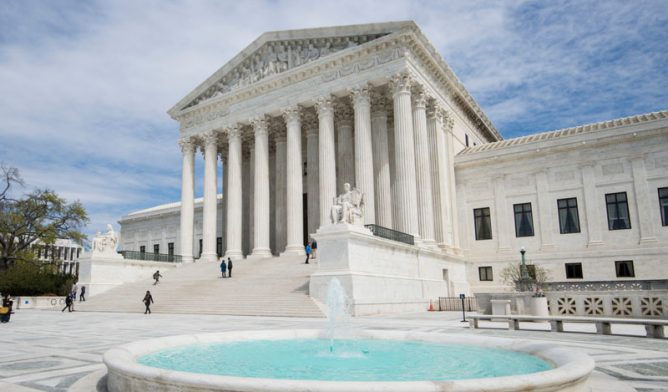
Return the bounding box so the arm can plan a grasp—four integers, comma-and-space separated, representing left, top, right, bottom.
427, 101, 448, 249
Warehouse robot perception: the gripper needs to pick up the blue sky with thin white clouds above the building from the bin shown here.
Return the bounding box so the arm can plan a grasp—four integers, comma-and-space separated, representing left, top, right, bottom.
0, 0, 668, 240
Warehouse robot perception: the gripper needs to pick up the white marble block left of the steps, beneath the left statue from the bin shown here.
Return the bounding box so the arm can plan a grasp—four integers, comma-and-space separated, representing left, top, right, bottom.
78, 255, 181, 297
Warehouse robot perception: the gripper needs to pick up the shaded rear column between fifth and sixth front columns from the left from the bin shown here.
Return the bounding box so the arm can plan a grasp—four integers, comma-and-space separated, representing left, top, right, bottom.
304, 112, 320, 234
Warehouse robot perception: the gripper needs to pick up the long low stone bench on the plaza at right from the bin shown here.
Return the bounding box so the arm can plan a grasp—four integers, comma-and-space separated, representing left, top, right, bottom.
469, 315, 668, 338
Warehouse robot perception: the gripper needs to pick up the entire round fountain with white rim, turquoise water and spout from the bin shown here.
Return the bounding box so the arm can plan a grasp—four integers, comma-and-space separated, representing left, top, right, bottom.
104, 278, 594, 392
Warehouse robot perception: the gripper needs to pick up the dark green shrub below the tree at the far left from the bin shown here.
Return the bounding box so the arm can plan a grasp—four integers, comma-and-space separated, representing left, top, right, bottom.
0, 261, 77, 296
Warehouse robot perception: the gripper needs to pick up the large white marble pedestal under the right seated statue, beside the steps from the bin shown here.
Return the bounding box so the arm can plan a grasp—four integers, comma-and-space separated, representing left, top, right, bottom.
309, 224, 471, 316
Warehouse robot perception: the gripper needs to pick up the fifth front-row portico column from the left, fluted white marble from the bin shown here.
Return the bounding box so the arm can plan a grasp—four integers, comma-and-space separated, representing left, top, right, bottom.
283, 106, 304, 255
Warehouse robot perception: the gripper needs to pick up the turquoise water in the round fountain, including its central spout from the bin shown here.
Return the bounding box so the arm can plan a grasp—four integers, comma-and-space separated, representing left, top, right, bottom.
138, 278, 553, 381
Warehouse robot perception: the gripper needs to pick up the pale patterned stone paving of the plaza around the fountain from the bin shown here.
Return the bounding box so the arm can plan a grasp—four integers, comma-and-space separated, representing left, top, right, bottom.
0, 310, 668, 392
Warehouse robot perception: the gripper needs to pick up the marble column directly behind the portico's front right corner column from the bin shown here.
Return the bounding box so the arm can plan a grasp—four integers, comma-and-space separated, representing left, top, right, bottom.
412, 89, 436, 245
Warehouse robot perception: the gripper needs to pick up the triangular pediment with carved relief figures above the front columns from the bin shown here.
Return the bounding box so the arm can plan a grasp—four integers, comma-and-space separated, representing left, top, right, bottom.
170, 21, 415, 114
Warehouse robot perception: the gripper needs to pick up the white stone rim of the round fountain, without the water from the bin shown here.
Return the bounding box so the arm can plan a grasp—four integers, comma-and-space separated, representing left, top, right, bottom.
104, 330, 594, 392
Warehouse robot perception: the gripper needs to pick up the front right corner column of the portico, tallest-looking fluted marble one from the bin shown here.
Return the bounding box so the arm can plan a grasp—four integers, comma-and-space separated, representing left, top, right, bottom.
392, 74, 420, 239
